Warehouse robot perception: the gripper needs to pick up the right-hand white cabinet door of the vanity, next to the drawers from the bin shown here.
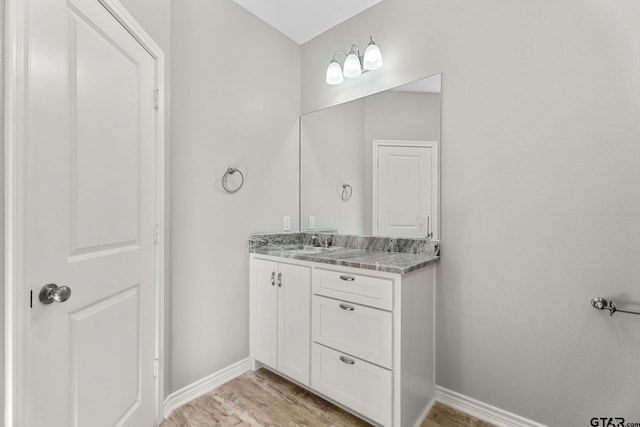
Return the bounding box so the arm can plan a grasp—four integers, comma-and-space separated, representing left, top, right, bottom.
278, 264, 311, 385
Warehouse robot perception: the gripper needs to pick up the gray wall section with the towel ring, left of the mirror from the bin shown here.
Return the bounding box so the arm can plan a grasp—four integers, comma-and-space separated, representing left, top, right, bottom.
169, 0, 300, 391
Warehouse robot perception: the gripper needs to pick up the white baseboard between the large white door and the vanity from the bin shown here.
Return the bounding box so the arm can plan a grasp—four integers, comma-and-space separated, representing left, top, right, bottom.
162, 358, 250, 419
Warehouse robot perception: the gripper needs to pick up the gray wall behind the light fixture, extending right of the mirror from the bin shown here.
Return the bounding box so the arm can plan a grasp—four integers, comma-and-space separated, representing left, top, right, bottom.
302, 0, 640, 426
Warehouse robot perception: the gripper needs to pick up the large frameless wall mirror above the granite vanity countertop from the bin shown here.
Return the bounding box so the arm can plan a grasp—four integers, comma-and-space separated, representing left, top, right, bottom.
300, 74, 442, 239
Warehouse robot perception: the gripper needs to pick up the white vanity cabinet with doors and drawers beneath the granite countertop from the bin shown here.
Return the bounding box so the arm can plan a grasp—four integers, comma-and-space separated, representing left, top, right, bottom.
251, 254, 435, 427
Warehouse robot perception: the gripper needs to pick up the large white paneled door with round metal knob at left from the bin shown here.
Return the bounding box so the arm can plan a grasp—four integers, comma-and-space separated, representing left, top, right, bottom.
21, 0, 158, 427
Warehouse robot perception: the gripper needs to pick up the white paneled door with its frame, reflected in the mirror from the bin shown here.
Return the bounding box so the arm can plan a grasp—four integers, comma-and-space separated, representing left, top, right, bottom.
373, 141, 438, 237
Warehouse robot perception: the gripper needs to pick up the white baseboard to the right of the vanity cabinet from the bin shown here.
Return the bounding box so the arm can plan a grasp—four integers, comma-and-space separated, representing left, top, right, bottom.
436, 386, 546, 427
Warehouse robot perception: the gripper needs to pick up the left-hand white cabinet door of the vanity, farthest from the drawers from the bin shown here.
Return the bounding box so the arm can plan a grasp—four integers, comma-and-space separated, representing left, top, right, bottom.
250, 259, 278, 369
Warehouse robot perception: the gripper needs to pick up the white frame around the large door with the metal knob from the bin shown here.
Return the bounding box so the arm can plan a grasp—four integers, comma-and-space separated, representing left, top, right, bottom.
4, 0, 165, 427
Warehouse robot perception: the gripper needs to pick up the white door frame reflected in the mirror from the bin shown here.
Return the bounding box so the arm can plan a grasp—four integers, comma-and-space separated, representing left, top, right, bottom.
371, 139, 440, 239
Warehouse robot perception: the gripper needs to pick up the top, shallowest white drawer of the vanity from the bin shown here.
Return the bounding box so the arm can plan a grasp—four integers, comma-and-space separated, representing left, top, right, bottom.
312, 268, 393, 310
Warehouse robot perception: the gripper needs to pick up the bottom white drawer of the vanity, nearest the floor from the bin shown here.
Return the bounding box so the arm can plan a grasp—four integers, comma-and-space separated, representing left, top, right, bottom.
311, 343, 393, 426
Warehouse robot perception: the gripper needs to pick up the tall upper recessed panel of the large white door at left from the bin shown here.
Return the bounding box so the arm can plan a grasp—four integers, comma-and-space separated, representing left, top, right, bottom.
69, 11, 140, 255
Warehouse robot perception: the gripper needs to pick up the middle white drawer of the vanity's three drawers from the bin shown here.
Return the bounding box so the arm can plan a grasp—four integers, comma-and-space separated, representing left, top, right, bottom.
311, 295, 393, 368
